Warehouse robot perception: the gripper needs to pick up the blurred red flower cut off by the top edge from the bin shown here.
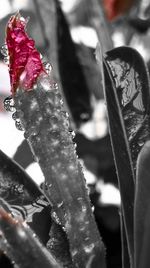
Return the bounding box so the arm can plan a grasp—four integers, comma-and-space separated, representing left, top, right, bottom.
103, 0, 134, 21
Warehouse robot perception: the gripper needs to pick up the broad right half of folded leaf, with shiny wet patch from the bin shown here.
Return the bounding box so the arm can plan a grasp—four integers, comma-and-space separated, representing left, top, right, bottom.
106, 47, 150, 170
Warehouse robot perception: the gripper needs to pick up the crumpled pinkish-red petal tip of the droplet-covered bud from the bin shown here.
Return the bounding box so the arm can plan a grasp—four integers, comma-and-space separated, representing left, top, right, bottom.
6, 13, 45, 94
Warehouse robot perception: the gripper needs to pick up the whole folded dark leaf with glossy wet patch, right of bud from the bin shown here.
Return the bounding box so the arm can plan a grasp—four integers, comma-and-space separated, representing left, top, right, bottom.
102, 47, 149, 264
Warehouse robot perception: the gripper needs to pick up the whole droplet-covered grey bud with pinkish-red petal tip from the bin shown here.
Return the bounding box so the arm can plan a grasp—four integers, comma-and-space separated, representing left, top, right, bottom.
5, 14, 105, 268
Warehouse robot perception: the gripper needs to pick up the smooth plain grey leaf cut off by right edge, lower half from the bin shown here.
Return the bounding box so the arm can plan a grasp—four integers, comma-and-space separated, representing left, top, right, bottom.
134, 141, 150, 268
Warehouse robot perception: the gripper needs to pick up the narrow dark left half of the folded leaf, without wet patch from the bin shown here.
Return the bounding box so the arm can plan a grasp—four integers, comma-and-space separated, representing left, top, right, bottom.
104, 57, 134, 262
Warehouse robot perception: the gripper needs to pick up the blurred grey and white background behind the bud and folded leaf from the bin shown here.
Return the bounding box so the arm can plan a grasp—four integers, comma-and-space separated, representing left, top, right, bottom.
0, 0, 150, 268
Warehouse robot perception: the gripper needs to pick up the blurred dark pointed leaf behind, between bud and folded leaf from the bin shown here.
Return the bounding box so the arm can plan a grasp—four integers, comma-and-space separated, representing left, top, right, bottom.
56, 1, 92, 124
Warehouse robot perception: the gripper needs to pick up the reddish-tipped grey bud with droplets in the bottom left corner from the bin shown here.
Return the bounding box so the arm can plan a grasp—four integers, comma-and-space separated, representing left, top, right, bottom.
0, 208, 60, 268
